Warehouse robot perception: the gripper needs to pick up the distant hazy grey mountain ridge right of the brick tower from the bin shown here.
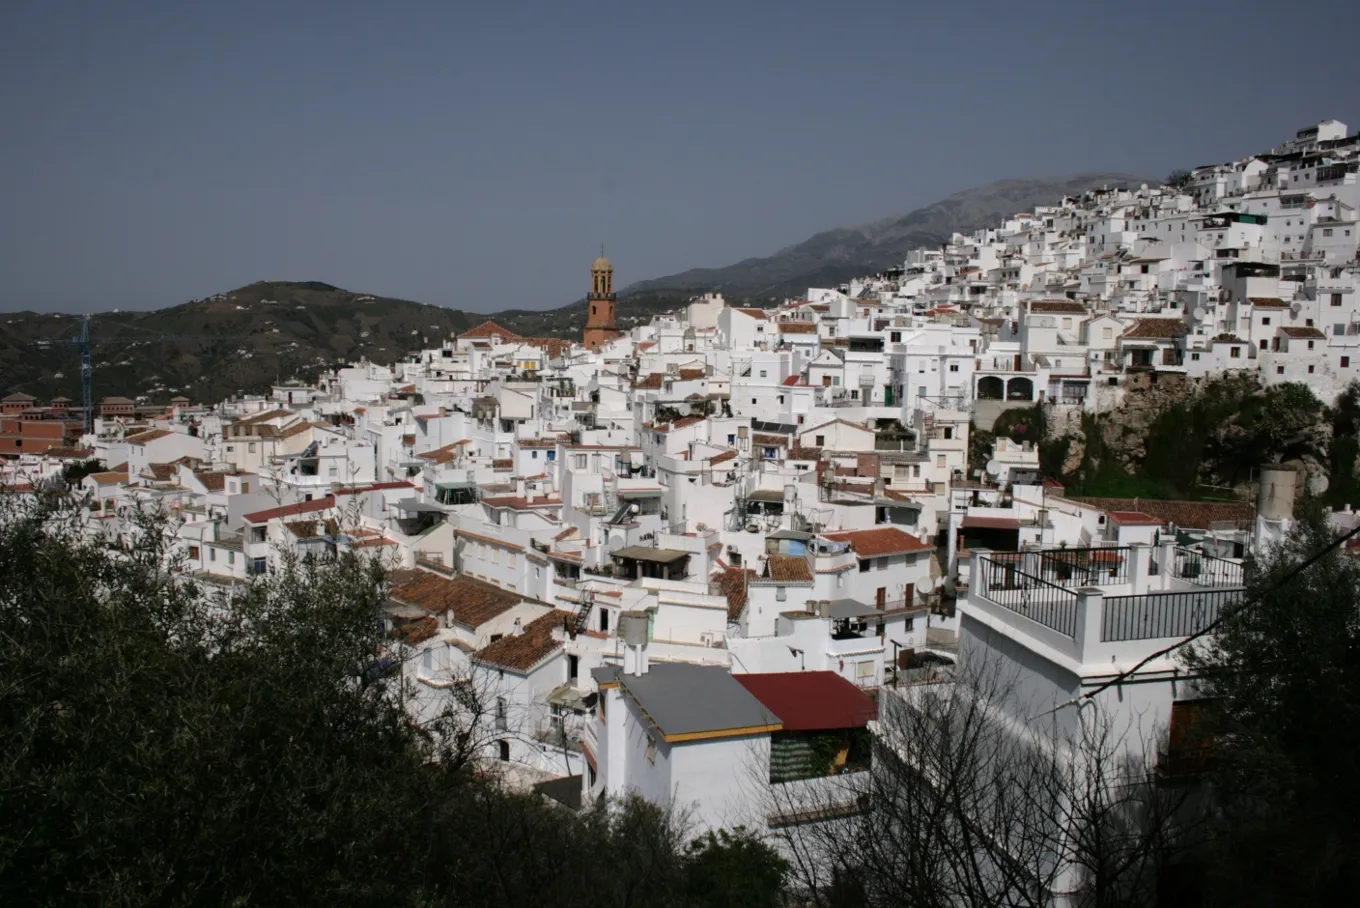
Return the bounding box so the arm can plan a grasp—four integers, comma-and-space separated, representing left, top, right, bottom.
622, 173, 1157, 298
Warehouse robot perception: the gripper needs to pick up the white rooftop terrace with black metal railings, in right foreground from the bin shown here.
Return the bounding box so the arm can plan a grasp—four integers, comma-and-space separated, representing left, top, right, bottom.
960, 542, 1244, 670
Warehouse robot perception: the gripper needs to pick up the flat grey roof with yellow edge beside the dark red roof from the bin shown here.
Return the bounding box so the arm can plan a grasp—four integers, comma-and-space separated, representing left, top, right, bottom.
616, 662, 779, 738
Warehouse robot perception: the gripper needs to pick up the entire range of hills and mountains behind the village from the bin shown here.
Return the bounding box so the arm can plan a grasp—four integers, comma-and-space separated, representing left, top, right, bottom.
0, 173, 1148, 401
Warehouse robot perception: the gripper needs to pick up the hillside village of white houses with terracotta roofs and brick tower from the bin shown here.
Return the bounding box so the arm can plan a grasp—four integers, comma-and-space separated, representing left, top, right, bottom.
0, 121, 1360, 897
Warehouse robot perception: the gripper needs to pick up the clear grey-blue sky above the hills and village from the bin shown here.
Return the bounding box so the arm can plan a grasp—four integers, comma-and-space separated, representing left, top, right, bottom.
0, 0, 1360, 311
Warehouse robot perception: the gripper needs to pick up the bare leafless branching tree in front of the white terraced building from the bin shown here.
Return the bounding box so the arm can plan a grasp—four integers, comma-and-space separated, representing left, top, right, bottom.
770, 663, 1185, 908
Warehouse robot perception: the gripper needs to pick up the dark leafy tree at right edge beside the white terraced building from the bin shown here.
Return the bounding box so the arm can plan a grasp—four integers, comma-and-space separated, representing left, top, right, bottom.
1185, 514, 1360, 905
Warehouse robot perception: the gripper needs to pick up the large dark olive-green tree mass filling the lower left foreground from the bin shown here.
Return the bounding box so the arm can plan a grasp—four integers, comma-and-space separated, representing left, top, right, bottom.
0, 495, 779, 908
